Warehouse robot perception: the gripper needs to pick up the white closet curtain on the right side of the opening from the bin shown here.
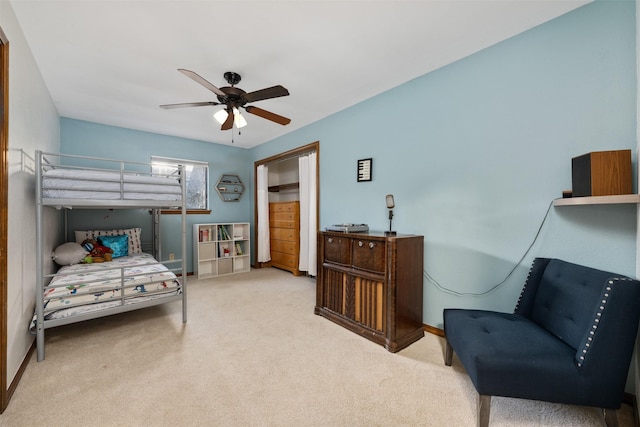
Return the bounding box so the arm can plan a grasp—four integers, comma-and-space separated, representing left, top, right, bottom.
298, 153, 318, 276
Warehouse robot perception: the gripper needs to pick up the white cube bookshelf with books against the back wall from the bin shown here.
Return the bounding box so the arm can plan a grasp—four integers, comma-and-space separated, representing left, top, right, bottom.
193, 222, 251, 279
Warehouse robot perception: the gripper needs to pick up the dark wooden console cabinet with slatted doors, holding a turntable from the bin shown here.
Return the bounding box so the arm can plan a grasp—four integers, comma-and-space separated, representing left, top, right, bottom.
315, 231, 424, 353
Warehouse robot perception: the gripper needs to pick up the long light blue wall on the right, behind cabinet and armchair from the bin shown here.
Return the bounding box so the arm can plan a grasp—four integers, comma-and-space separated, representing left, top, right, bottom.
251, 1, 637, 327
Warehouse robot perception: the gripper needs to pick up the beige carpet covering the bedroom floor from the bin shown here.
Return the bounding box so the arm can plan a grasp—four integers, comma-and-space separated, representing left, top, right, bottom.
0, 269, 633, 427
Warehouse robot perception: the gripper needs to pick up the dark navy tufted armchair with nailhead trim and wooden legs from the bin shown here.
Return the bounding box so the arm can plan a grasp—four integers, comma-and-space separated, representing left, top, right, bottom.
444, 258, 640, 426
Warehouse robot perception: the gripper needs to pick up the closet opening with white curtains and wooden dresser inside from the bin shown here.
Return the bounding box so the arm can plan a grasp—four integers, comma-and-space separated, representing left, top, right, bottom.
253, 141, 320, 276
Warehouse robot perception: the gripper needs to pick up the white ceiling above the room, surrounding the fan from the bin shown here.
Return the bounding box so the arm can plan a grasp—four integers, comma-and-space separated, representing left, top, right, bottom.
11, 0, 591, 148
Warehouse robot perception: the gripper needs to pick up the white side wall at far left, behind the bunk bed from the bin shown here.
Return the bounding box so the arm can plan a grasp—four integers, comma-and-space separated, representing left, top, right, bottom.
0, 0, 60, 386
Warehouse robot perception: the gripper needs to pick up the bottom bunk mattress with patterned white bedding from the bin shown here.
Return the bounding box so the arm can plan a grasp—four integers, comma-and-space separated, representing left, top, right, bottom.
29, 253, 182, 334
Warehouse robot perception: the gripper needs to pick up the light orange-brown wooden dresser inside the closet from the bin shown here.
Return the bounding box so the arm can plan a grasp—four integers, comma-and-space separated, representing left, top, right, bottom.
269, 201, 302, 276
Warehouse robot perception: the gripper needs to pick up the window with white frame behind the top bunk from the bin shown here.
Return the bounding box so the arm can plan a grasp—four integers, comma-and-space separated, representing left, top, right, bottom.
151, 156, 209, 210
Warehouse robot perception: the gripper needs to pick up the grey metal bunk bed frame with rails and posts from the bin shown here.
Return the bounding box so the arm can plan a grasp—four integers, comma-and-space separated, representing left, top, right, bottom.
36, 150, 187, 362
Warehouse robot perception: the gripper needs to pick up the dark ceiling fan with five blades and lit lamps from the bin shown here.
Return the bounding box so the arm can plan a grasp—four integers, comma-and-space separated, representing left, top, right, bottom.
160, 68, 291, 130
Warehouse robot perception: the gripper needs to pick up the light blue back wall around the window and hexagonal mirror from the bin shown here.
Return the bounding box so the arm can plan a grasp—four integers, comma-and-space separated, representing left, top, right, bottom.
60, 118, 253, 271
